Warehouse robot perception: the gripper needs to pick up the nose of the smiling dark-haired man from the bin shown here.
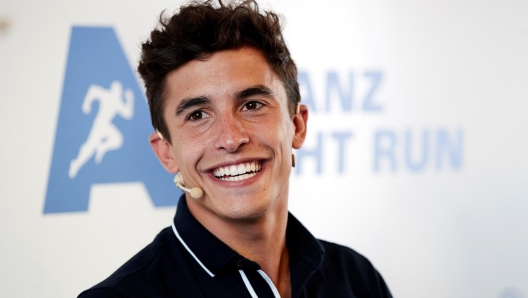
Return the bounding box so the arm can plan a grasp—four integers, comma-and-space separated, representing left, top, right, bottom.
215, 115, 249, 152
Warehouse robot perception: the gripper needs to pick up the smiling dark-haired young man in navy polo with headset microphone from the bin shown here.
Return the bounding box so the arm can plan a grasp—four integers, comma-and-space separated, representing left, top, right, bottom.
80, 1, 391, 297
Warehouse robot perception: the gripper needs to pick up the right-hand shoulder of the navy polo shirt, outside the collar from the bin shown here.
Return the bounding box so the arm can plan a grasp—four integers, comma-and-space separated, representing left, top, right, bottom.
309, 240, 392, 298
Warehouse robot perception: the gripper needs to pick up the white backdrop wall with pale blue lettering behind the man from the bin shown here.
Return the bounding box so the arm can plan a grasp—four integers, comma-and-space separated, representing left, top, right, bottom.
0, 0, 528, 298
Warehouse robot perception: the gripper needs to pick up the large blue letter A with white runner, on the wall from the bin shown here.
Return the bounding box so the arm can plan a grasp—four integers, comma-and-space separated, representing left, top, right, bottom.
44, 27, 181, 213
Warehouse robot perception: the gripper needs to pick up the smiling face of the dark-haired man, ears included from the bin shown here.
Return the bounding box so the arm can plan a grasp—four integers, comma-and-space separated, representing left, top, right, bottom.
155, 47, 307, 219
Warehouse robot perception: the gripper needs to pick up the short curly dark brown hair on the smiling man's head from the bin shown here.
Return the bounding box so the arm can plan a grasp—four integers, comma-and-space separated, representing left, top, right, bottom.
138, 0, 301, 143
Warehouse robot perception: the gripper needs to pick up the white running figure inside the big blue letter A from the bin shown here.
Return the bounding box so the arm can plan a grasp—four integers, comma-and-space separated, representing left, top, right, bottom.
68, 81, 134, 179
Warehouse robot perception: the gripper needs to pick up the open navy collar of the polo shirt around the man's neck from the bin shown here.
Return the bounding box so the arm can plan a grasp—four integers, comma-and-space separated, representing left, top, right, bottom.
173, 195, 324, 280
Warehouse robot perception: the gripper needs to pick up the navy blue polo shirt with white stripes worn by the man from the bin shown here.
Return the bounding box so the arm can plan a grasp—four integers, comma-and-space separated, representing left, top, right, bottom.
79, 196, 392, 298
